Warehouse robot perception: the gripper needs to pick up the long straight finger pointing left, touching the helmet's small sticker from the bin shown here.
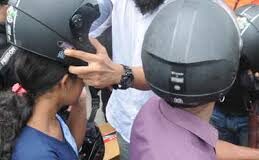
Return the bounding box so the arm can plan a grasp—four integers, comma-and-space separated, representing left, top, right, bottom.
65, 49, 99, 62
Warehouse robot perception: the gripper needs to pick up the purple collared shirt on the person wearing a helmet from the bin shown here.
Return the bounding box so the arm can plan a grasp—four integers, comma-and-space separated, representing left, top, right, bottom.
130, 97, 218, 160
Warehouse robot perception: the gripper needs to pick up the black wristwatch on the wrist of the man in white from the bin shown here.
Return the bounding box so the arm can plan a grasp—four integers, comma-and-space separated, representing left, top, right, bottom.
113, 64, 134, 89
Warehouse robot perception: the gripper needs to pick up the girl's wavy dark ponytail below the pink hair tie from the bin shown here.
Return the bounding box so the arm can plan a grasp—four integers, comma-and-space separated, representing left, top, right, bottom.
0, 91, 33, 160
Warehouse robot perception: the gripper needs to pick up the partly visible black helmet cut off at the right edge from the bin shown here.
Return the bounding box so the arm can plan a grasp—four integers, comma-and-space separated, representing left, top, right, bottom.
236, 4, 259, 71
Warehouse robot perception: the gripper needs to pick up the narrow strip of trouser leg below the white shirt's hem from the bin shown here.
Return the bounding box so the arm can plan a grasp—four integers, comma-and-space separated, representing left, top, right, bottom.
117, 132, 129, 160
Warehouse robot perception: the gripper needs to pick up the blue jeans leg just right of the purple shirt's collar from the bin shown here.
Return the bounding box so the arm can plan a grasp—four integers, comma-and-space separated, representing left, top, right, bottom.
210, 106, 235, 143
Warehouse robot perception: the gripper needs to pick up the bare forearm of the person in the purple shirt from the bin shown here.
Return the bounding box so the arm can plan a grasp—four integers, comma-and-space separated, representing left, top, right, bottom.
216, 140, 259, 160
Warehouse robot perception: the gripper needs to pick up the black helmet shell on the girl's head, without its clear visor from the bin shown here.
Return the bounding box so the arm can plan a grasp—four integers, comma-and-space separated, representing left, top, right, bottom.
6, 0, 111, 65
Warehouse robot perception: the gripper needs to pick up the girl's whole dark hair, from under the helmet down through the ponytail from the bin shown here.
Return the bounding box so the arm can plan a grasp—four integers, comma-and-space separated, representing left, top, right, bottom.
0, 49, 71, 160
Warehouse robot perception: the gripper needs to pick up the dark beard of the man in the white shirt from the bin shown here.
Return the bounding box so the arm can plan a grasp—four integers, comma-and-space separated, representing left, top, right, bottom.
134, 0, 165, 15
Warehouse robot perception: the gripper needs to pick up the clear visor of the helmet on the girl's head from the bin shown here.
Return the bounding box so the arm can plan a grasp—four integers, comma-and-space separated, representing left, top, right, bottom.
89, 0, 113, 38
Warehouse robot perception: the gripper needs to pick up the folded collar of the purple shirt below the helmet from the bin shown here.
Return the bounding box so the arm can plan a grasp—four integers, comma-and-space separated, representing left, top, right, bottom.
159, 96, 218, 148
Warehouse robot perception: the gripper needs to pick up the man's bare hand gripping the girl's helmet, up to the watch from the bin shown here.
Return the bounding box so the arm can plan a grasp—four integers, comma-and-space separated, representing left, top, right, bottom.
65, 38, 124, 88
